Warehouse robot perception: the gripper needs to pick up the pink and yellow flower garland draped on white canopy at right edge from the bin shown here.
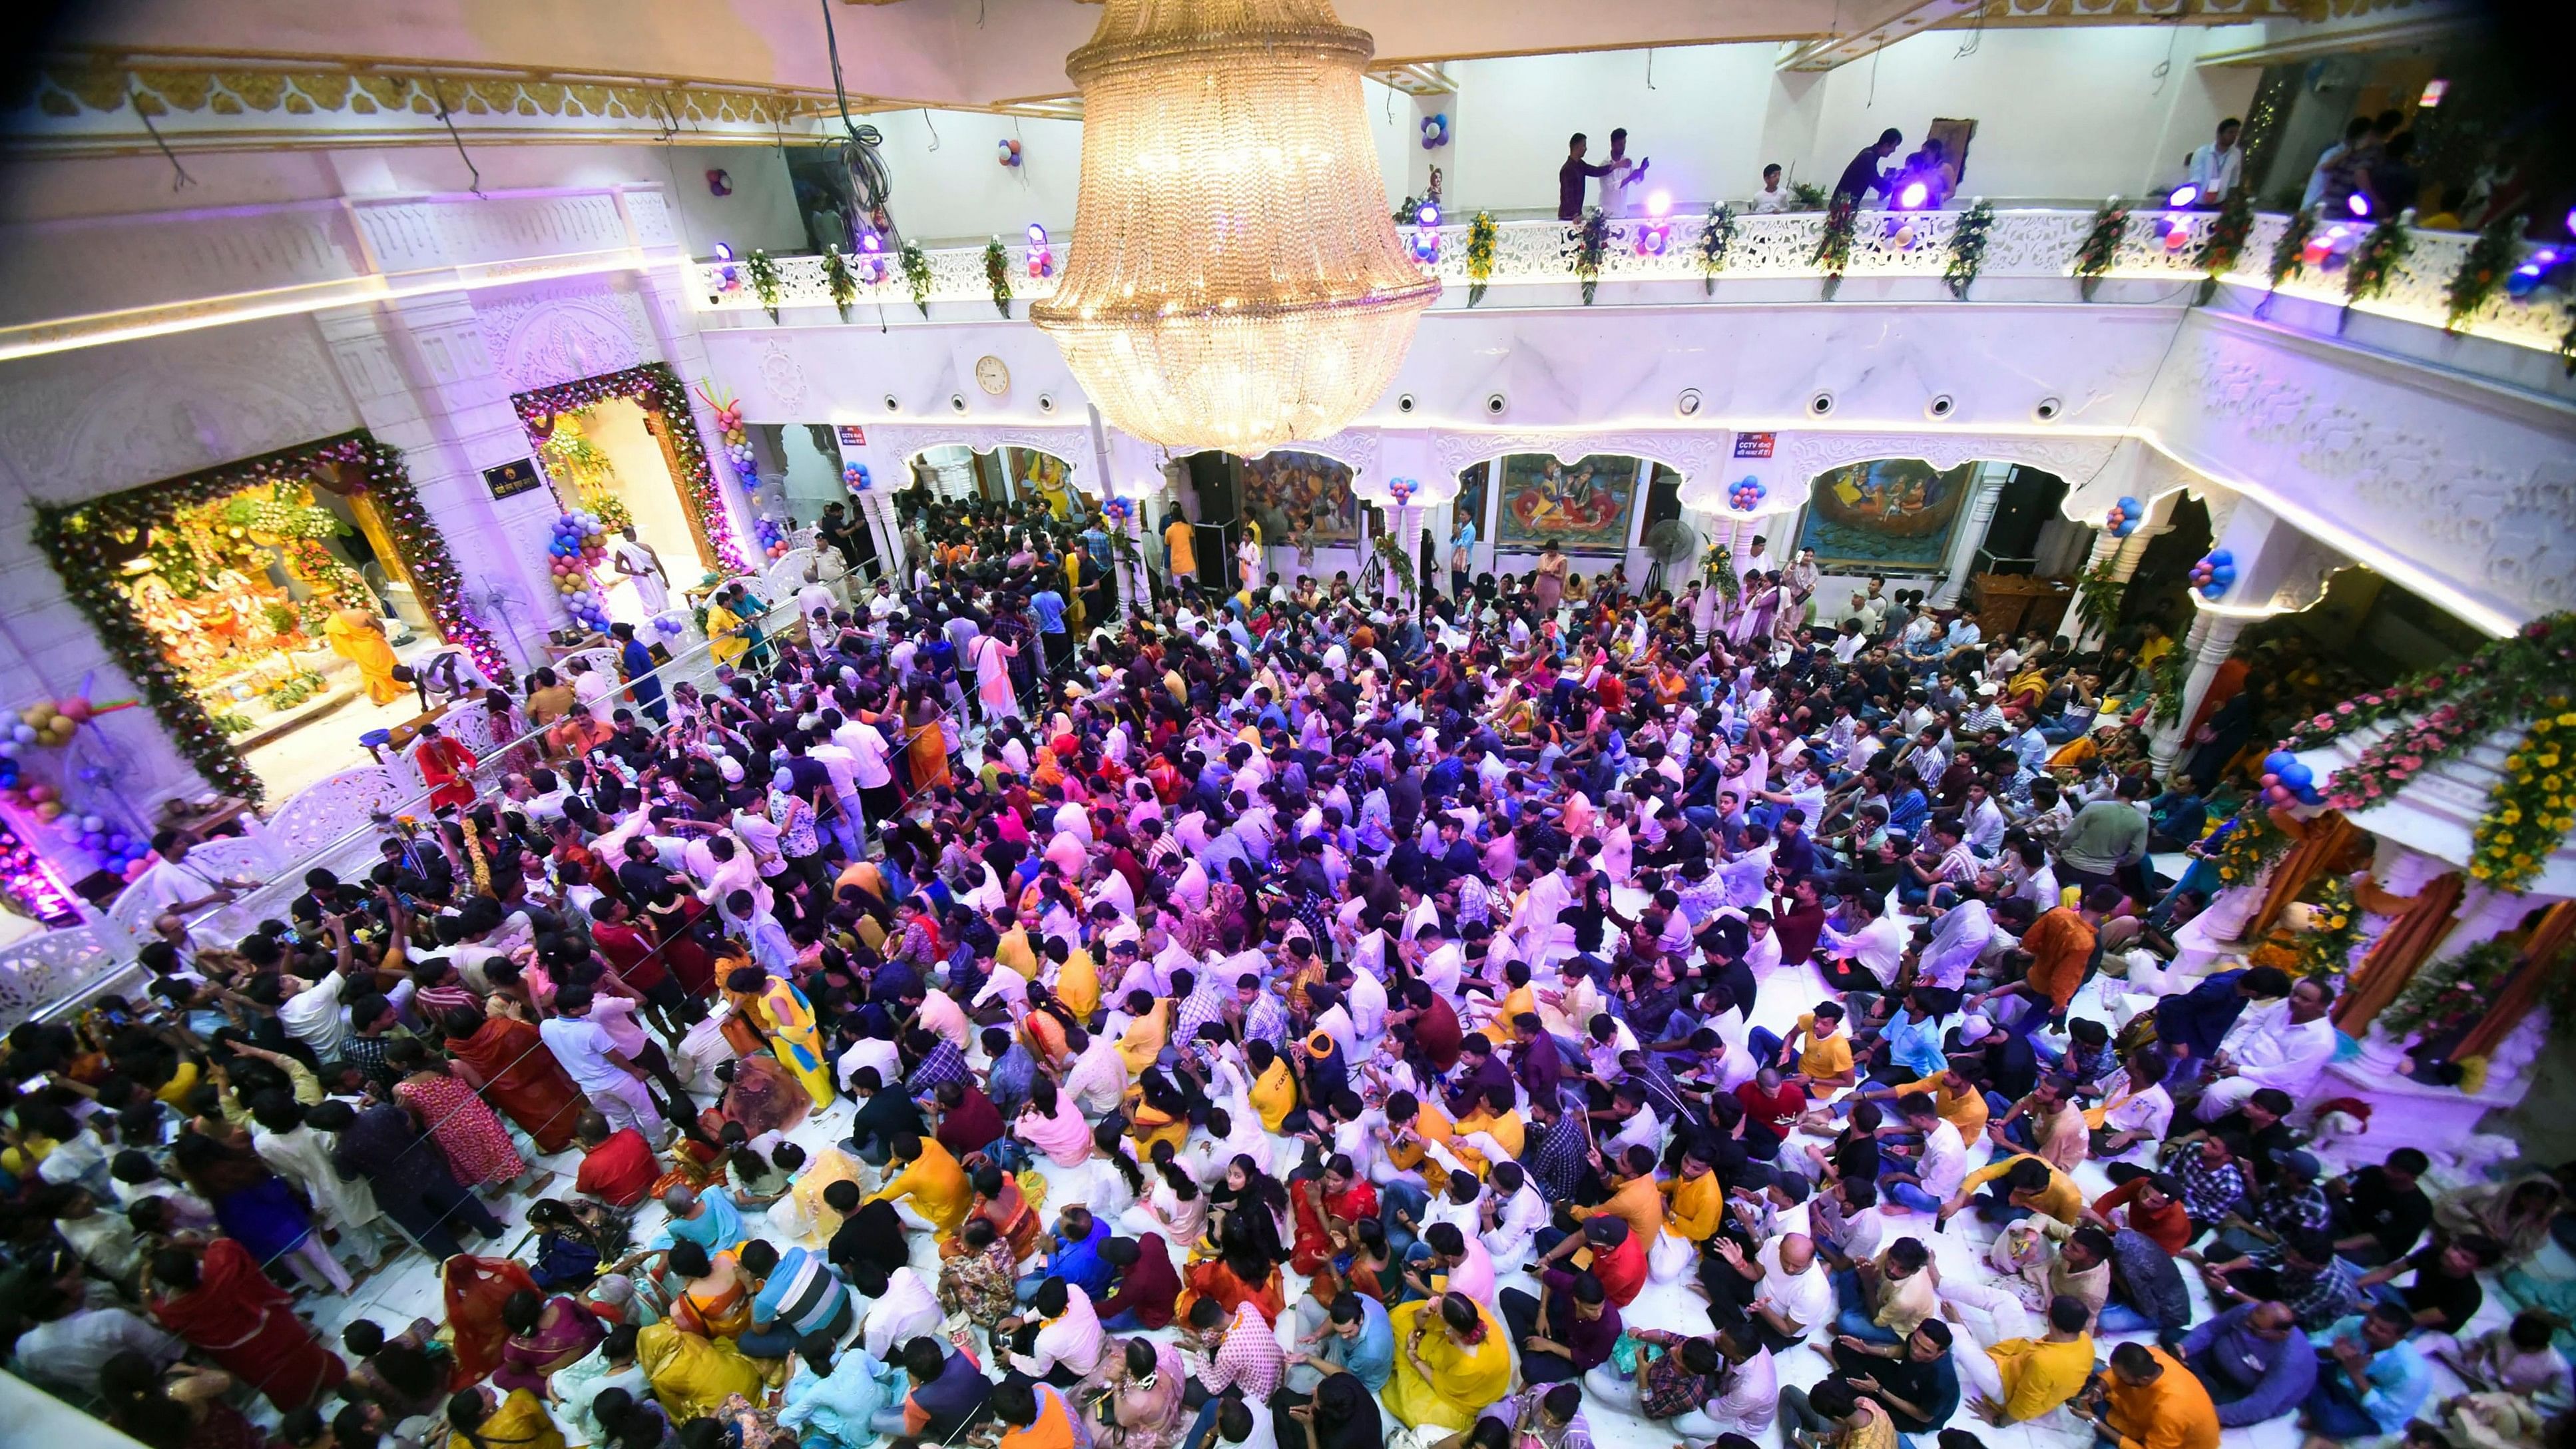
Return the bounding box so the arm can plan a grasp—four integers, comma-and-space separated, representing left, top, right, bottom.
2280, 603, 2576, 890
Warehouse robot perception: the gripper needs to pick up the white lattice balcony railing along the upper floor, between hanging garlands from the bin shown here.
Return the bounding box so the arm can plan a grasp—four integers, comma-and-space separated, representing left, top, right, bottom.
693, 209, 2568, 351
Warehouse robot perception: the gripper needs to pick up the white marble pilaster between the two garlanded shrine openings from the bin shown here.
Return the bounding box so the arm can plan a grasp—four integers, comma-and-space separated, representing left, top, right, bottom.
314, 292, 567, 671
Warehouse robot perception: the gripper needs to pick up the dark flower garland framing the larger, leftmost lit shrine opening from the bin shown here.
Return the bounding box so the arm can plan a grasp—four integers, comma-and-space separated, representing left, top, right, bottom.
36, 431, 510, 804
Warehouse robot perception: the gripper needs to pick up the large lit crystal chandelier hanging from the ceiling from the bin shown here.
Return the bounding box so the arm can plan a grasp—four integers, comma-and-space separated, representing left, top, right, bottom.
1031, 0, 1440, 453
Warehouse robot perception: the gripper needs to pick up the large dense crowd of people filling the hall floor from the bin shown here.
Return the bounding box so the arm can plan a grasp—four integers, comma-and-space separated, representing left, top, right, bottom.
0, 487, 2568, 1449
